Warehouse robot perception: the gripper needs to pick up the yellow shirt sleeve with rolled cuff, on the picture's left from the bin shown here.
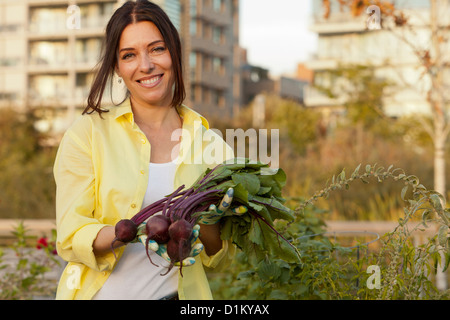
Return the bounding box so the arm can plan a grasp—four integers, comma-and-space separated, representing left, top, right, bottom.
53, 119, 115, 271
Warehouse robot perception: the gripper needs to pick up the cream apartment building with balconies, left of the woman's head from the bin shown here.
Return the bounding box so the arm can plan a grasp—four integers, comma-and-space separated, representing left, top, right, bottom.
0, 0, 116, 132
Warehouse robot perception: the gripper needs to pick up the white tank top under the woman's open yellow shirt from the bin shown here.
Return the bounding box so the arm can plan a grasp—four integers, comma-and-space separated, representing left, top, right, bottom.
93, 162, 178, 300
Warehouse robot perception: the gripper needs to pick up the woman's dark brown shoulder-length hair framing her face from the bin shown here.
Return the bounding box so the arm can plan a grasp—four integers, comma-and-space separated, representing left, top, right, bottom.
83, 0, 186, 115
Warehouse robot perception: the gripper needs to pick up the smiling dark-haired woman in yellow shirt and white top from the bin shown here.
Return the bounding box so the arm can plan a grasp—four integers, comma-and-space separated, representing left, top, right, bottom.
54, 0, 235, 299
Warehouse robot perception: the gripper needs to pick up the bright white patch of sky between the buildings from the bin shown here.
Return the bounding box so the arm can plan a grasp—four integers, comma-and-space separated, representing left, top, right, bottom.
239, 0, 317, 76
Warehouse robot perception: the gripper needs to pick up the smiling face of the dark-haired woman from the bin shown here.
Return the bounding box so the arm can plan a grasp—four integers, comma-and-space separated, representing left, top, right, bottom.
116, 21, 174, 106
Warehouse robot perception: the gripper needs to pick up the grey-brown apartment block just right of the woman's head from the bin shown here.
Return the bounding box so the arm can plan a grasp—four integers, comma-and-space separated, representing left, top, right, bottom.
186, 0, 241, 118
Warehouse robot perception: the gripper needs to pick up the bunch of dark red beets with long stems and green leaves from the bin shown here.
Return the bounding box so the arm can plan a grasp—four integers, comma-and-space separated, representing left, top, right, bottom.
111, 158, 299, 271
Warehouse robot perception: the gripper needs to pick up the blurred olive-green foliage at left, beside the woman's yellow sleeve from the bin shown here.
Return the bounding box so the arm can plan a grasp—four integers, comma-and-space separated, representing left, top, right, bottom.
0, 109, 55, 219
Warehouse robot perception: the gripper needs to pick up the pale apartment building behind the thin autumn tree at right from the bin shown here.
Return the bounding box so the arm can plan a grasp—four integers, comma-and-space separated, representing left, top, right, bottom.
304, 0, 450, 117
